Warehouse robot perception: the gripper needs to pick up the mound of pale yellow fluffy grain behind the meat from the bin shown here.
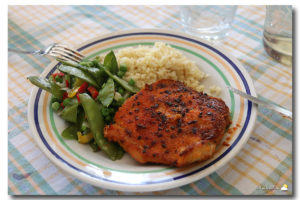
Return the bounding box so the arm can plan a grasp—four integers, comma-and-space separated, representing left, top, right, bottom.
116, 42, 207, 92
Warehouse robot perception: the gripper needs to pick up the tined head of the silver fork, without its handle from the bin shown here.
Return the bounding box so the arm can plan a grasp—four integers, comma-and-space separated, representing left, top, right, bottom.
49, 44, 84, 63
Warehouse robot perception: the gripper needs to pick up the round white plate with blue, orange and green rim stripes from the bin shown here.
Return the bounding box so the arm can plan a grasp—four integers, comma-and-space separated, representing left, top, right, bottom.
28, 29, 257, 192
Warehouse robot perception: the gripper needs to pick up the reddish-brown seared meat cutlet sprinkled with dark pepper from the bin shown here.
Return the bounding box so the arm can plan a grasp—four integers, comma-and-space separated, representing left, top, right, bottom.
104, 80, 231, 167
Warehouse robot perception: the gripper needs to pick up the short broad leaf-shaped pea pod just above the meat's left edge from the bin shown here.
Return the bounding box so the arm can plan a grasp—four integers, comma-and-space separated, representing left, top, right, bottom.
98, 78, 115, 107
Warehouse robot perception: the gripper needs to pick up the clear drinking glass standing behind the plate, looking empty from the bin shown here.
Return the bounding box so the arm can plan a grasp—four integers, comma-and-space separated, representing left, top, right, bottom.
180, 5, 237, 41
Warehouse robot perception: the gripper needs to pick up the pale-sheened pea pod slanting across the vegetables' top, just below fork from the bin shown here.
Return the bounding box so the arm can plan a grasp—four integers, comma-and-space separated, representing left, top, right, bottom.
58, 65, 99, 89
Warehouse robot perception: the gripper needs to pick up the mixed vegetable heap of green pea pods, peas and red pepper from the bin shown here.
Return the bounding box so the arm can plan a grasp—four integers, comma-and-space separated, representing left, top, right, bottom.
28, 51, 139, 160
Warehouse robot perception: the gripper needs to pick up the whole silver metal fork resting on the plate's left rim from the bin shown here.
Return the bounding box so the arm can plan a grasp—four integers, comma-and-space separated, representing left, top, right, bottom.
8, 43, 84, 63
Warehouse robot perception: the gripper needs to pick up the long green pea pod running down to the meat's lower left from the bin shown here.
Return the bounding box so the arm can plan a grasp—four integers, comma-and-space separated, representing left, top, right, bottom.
79, 93, 124, 160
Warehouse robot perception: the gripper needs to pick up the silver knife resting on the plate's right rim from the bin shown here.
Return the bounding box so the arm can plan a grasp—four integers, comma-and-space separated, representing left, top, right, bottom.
226, 85, 293, 119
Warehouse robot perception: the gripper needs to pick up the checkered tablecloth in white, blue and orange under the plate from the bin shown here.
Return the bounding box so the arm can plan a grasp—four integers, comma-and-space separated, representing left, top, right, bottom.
8, 6, 293, 195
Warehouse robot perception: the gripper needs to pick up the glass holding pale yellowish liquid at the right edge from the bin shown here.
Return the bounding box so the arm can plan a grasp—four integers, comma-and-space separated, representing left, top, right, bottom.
263, 5, 293, 66
